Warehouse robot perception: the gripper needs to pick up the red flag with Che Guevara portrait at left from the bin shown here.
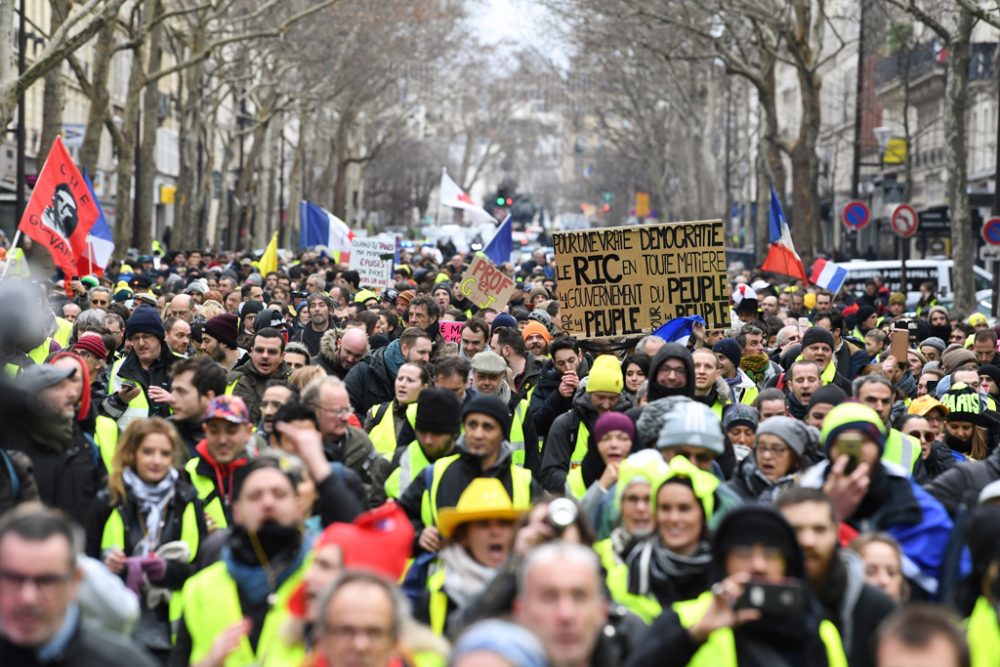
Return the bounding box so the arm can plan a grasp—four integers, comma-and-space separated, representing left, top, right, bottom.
18, 136, 98, 280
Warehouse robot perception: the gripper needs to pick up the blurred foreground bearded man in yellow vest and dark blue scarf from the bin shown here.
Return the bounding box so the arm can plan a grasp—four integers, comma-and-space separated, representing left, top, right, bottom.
170, 458, 309, 665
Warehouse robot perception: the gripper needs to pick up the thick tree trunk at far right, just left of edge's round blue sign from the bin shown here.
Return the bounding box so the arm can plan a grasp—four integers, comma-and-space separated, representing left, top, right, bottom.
944, 9, 976, 313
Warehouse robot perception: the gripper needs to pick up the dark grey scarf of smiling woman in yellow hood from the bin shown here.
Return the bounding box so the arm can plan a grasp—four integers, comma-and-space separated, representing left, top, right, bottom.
628, 534, 712, 607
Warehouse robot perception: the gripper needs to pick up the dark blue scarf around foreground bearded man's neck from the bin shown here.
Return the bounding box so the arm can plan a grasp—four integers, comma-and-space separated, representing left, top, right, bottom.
220, 521, 311, 605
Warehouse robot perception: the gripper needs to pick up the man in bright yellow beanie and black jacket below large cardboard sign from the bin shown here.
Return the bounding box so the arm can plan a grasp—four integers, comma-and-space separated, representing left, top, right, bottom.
541, 354, 628, 497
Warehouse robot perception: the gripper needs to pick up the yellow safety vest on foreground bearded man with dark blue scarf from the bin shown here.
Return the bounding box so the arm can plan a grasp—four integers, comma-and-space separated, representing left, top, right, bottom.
180, 558, 309, 667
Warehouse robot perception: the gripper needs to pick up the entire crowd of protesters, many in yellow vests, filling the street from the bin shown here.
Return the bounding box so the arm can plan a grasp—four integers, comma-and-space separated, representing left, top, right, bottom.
0, 248, 1000, 667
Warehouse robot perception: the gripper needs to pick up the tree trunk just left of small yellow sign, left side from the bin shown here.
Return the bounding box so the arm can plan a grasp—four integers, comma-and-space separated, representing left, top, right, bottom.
134, 0, 163, 252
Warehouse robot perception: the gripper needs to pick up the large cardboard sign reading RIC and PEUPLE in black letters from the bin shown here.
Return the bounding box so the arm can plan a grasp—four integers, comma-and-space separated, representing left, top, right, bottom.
553, 220, 729, 338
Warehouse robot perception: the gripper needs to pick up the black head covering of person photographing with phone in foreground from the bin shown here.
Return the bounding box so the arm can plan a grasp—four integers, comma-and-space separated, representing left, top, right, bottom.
712, 505, 805, 581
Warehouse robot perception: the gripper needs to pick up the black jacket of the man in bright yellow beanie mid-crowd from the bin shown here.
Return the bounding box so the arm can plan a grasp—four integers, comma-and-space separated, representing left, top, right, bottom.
541, 386, 632, 495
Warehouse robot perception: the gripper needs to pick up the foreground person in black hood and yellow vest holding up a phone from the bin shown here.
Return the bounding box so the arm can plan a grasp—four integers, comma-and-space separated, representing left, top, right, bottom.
625, 505, 848, 667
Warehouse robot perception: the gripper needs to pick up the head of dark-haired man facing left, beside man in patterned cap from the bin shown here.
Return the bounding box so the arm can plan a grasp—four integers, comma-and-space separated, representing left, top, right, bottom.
170, 356, 226, 456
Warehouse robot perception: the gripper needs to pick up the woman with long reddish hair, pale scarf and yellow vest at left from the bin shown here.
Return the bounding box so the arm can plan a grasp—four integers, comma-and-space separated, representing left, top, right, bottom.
87, 417, 208, 664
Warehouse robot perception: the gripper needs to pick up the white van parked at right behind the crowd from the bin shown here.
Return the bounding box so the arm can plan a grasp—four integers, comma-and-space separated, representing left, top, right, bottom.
838, 259, 993, 311
